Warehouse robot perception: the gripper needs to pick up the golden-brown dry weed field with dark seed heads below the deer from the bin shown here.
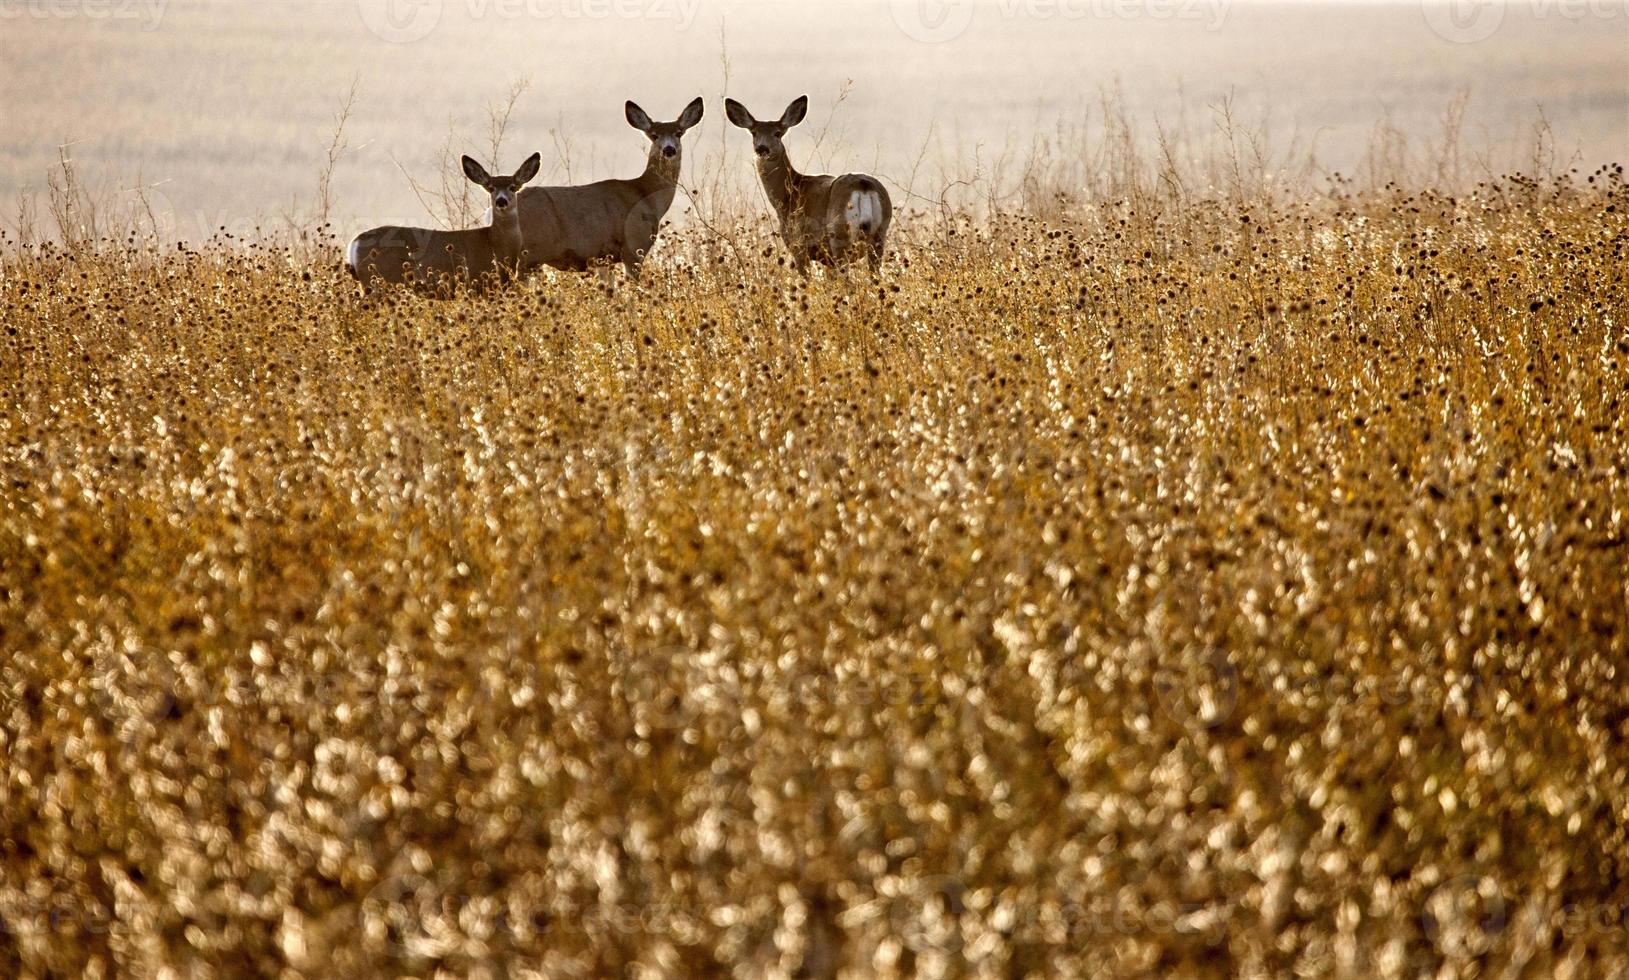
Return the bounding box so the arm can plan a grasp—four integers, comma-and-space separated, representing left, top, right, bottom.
0, 154, 1629, 978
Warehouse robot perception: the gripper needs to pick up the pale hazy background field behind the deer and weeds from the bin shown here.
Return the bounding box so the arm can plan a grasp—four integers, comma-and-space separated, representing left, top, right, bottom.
0, 0, 1629, 238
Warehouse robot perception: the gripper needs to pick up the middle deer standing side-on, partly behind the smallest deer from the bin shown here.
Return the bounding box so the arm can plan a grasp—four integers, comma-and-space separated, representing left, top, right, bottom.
504, 96, 704, 280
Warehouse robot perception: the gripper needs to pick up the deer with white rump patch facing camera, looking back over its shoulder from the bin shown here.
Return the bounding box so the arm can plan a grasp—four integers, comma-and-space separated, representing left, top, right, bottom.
723, 96, 894, 275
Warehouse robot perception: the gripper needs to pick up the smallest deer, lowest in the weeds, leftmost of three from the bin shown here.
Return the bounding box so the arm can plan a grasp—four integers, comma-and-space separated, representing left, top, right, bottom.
345, 153, 542, 295
